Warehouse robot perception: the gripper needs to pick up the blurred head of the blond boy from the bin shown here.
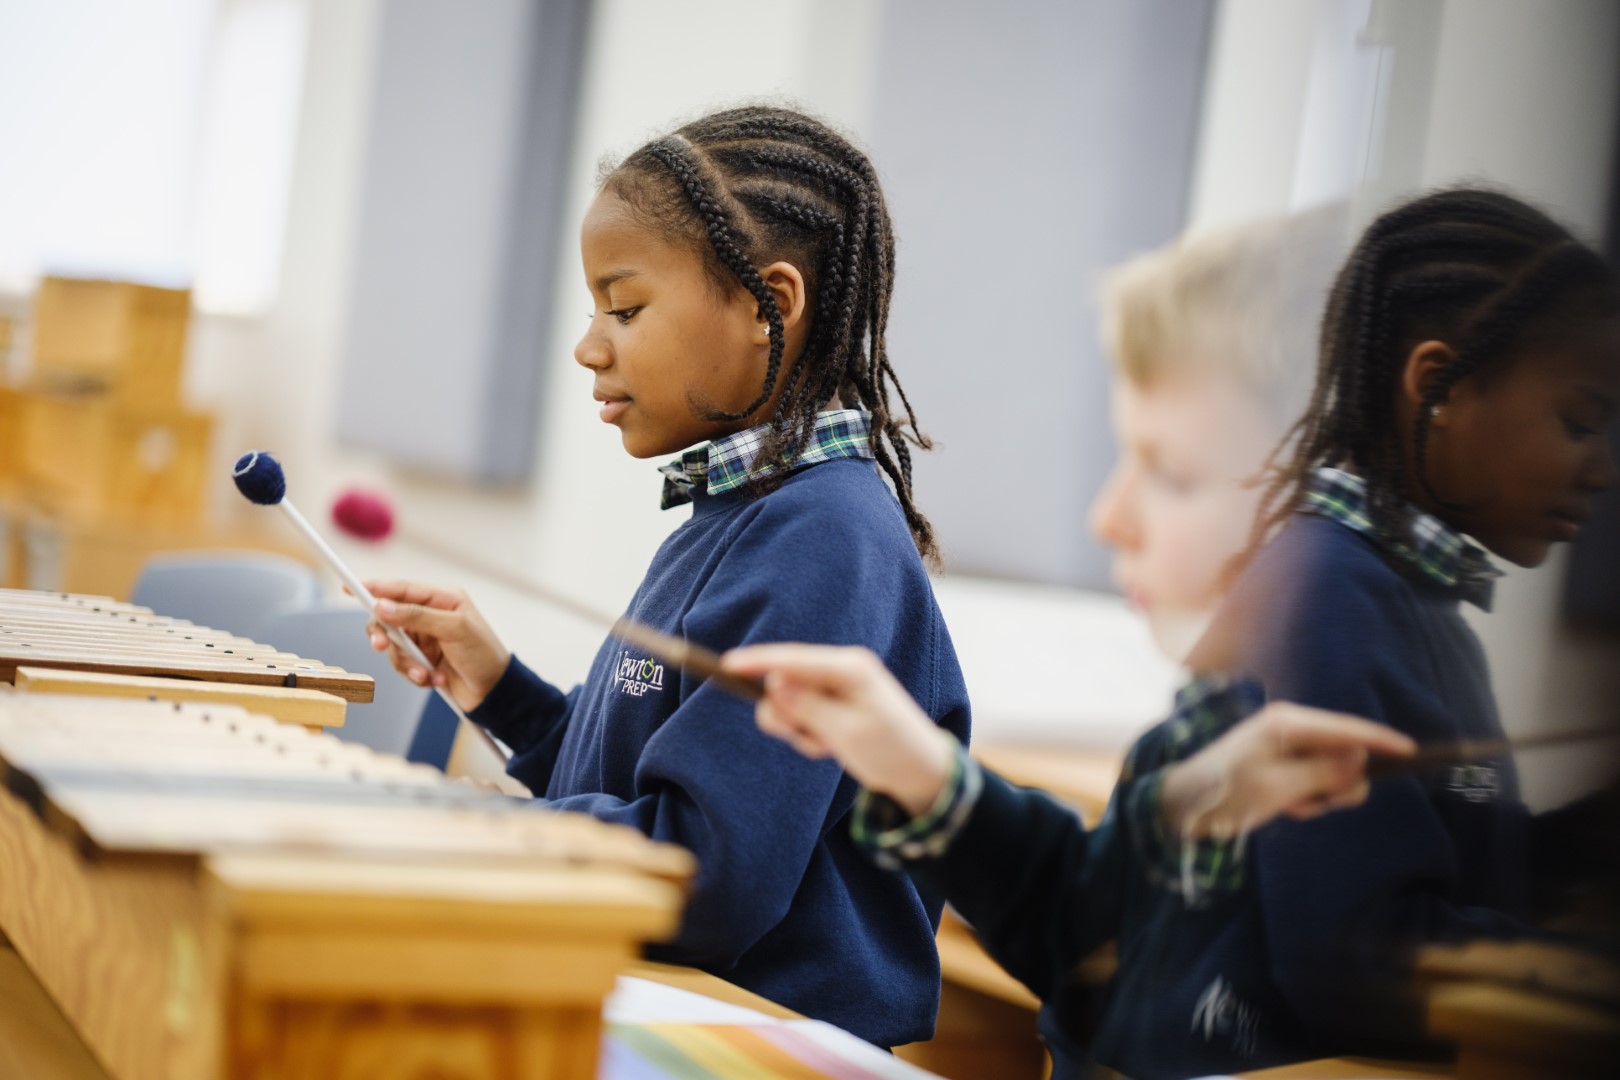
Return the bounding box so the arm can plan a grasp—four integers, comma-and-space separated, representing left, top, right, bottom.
1090, 204, 1348, 661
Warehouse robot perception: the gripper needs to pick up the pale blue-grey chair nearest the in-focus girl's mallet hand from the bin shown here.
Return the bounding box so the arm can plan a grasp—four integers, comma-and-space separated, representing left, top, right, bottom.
256, 604, 427, 758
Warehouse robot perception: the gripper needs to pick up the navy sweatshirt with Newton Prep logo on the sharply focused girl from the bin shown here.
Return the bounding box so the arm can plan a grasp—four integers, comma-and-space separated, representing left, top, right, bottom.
473, 458, 969, 1046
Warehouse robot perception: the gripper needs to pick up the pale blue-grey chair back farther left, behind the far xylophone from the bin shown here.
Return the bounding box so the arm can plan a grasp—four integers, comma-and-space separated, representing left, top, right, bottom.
131, 552, 321, 638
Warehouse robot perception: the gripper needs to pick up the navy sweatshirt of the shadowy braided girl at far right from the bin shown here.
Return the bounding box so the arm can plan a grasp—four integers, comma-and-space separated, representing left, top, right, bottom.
1192, 515, 1533, 1057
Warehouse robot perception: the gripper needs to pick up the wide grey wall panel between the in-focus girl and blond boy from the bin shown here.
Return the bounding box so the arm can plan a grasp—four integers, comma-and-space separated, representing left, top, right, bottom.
870, 0, 1210, 588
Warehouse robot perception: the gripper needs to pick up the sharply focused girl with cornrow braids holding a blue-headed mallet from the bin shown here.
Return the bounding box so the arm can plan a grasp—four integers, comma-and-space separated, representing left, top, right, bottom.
362, 107, 969, 1046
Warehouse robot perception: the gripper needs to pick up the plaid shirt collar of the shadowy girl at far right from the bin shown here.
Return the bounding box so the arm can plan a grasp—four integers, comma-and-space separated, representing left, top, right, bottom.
1304, 468, 1502, 610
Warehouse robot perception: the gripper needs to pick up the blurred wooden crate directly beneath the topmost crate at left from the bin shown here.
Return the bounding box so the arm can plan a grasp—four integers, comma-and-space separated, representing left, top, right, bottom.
15, 389, 214, 525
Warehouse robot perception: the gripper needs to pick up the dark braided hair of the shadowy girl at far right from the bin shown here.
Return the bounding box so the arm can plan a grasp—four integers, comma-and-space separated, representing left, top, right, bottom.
1243, 188, 1620, 557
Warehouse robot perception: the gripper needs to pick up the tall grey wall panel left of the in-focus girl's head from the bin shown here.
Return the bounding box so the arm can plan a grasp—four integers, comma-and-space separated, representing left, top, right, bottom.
337, 0, 588, 481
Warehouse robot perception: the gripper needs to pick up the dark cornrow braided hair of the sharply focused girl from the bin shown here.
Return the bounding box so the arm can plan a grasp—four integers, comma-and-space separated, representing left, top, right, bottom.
603, 107, 938, 562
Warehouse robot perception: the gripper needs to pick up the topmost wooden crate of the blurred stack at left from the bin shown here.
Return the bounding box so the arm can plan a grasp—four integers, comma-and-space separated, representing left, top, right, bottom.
34, 277, 191, 405
